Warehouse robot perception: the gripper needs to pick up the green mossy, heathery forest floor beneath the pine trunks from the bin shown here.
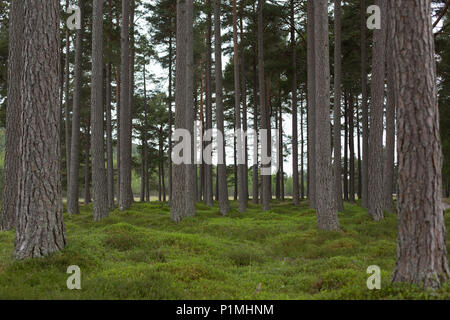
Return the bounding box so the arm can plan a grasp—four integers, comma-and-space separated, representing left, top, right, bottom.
0, 201, 450, 299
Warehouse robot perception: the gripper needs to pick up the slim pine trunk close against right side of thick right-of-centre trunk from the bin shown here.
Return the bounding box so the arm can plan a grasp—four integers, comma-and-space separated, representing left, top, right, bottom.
333, 0, 344, 211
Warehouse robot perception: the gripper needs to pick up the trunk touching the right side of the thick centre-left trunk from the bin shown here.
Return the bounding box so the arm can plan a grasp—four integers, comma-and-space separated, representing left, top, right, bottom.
185, 0, 197, 216
